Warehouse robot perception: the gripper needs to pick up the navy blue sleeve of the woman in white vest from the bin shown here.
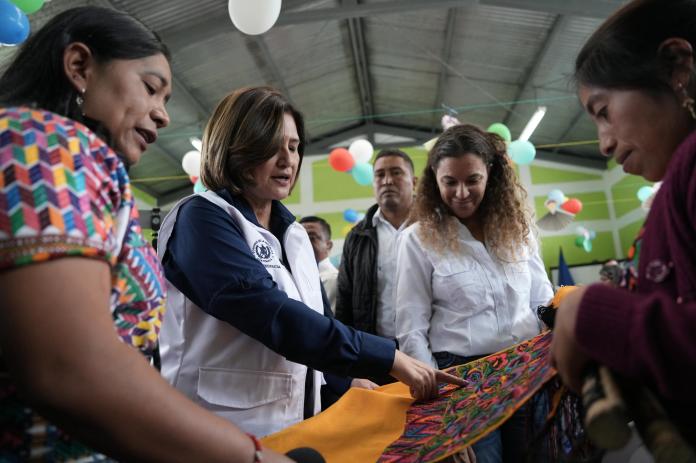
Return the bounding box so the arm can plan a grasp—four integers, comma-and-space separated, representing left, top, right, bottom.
163, 198, 395, 377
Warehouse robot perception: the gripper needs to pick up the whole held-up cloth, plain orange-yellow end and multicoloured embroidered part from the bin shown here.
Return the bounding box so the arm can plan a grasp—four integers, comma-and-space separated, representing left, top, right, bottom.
263, 332, 555, 463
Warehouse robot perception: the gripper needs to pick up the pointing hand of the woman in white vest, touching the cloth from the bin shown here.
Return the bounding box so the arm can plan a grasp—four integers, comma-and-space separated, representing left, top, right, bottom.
389, 350, 468, 400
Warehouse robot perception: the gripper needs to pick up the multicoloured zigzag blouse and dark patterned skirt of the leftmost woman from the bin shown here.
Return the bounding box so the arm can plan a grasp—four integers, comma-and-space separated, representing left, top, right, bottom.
0, 107, 165, 462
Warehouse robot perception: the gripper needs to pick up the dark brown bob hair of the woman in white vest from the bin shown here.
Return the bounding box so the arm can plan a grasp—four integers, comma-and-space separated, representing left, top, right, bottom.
201, 87, 306, 194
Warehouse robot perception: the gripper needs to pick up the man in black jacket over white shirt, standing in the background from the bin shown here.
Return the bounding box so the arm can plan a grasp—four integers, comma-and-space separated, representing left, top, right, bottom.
336, 149, 416, 383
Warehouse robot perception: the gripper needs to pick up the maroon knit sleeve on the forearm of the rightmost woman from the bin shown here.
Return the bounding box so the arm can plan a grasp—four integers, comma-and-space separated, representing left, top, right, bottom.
575, 284, 696, 399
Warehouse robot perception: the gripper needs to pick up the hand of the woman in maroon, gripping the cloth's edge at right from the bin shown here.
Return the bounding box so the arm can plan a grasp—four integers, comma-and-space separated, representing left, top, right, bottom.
551, 287, 590, 392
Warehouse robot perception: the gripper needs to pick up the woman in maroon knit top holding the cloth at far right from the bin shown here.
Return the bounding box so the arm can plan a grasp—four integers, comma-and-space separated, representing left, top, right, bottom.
552, 0, 696, 444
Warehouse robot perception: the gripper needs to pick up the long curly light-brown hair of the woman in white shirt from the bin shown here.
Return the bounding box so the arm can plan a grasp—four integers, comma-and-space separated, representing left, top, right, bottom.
409, 124, 531, 261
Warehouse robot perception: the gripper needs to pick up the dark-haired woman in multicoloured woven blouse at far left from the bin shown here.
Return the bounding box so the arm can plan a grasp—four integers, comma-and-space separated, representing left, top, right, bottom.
0, 7, 290, 463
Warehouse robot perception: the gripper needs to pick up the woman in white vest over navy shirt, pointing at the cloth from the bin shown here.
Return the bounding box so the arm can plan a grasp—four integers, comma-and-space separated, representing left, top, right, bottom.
158, 87, 461, 435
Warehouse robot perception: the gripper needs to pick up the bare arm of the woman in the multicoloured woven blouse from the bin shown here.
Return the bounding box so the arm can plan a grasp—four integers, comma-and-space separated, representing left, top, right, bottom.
0, 257, 292, 463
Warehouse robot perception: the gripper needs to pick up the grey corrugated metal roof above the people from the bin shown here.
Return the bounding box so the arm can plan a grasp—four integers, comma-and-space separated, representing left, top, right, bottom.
0, 0, 622, 203
